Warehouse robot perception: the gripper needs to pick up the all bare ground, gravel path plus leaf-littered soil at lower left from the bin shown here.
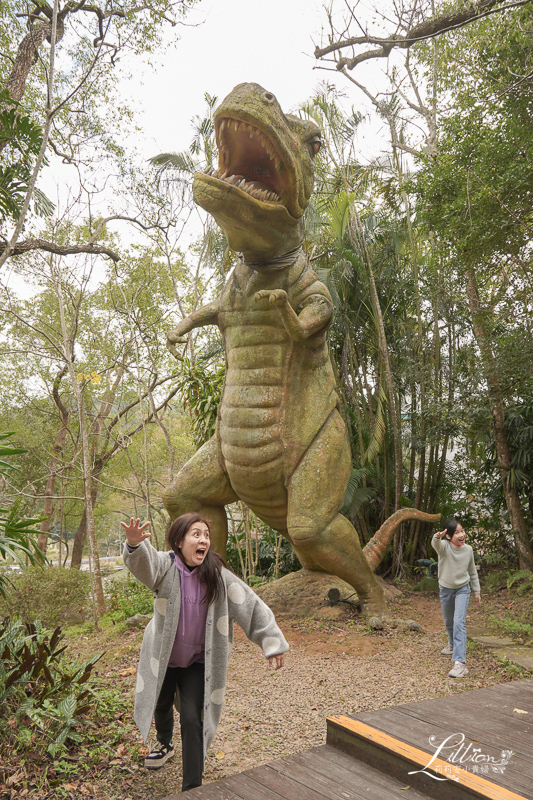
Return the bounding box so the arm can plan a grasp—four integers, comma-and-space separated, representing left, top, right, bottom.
0, 587, 531, 800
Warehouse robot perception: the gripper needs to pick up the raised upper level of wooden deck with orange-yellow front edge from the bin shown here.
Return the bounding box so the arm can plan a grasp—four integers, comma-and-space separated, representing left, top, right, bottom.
327, 679, 533, 800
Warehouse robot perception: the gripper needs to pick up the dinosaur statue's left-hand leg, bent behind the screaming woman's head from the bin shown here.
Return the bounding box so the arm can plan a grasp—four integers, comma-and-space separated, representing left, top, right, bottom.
163, 436, 238, 558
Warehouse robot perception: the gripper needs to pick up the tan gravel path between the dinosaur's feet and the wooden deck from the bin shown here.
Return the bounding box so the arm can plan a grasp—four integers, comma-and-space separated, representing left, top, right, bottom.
119, 595, 512, 800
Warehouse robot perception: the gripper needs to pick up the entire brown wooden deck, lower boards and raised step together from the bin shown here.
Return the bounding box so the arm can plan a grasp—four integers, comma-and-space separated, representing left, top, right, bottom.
166, 679, 533, 800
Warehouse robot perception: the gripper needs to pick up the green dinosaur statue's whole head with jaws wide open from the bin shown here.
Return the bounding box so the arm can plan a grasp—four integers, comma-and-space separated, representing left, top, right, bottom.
193, 83, 321, 262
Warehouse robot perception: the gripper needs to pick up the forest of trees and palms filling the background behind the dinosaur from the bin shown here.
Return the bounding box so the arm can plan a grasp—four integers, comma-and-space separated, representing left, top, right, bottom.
0, 0, 533, 614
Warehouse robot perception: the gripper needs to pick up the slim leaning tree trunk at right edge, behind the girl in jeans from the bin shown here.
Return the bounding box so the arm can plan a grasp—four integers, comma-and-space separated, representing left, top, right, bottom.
466, 269, 533, 570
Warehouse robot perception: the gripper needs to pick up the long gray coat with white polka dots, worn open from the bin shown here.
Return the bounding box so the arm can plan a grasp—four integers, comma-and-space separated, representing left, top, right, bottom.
124, 541, 289, 758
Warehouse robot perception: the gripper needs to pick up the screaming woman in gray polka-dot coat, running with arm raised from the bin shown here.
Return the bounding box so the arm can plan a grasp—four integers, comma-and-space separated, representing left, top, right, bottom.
121, 514, 289, 791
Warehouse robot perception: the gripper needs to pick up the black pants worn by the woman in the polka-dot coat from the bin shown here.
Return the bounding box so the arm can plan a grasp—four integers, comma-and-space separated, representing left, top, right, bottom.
154, 662, 205, 792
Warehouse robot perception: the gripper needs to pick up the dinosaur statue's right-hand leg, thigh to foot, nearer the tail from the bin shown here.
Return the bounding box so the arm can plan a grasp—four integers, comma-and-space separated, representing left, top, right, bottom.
287, 411, 387, 616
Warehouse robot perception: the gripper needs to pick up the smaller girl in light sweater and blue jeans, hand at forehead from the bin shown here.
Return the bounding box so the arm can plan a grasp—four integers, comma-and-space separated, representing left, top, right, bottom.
431, 519, 481, 678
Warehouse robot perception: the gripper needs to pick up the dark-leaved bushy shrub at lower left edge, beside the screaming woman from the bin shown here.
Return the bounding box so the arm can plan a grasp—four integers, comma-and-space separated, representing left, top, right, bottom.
0, 620, 101, 757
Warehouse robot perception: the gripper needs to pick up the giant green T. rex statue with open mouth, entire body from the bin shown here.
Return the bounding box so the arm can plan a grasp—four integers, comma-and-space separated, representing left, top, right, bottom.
163, 83, 438, 616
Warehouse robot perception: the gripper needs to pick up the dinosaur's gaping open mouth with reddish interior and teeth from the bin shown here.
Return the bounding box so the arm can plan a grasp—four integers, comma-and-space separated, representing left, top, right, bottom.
205, 117, 289, 203
